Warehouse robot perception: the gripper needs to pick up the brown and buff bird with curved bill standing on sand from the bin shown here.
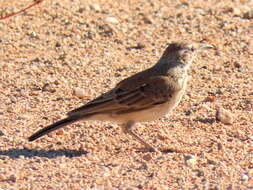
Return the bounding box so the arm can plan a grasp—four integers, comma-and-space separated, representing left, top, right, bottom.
28, 42, 213, 151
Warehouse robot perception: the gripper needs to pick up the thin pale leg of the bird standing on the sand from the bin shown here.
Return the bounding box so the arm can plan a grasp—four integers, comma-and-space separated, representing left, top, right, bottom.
122, 121, 159, 152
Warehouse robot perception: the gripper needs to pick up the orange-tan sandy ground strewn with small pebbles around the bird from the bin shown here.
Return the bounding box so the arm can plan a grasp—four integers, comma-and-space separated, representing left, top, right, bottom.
0, 0, 253, 190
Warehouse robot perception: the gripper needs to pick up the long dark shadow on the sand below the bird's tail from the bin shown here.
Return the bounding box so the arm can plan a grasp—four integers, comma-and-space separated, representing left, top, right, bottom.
0, 148, 88, 159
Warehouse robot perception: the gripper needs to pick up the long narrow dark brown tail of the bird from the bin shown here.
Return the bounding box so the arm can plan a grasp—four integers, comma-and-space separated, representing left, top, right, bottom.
28, 116, 83, 141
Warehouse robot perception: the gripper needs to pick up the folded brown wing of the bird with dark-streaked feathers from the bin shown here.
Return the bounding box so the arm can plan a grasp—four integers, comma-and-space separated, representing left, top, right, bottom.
68, 76, 175, 116
